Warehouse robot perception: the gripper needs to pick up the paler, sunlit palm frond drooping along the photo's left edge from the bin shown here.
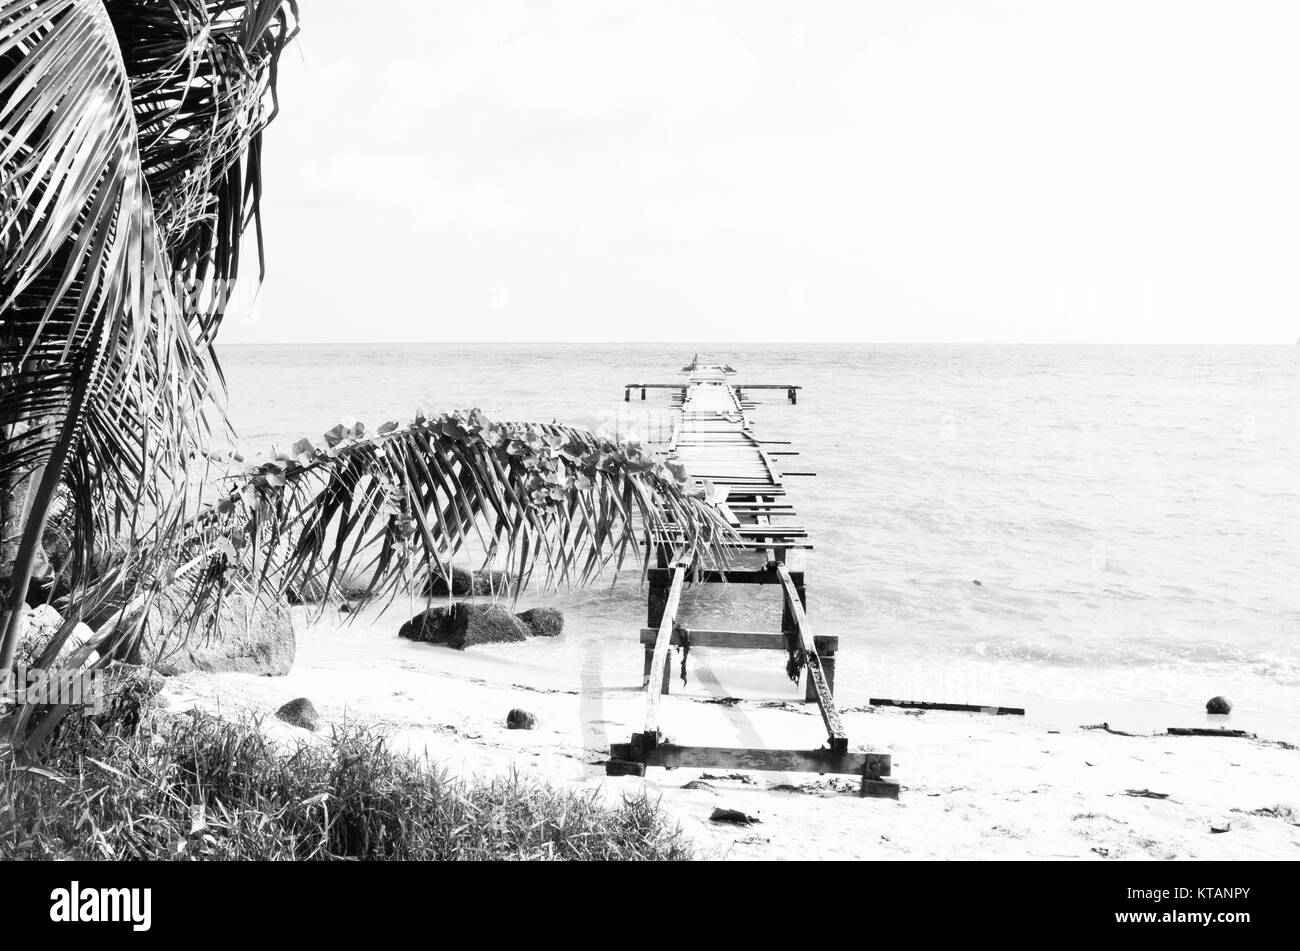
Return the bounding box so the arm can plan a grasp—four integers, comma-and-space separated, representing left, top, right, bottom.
0, 0, 179, 672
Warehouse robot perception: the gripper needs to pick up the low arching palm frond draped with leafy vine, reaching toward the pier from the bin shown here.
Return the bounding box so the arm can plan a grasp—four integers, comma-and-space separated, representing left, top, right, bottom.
204, 409, 735, 608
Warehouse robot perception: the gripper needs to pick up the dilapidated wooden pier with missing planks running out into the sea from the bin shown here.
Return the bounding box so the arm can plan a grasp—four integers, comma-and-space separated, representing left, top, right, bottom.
606, 356, 898, 798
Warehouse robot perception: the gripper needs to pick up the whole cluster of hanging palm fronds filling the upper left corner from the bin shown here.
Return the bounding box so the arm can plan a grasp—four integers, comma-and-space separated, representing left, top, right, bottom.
0, 0, 296, 685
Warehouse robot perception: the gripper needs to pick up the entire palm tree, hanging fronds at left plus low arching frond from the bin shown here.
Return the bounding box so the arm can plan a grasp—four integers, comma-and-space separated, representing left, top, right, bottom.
0, 0, 729, 747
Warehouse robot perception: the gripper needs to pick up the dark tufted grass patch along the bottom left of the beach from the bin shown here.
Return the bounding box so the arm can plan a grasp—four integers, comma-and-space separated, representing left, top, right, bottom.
0, 675, 693, 860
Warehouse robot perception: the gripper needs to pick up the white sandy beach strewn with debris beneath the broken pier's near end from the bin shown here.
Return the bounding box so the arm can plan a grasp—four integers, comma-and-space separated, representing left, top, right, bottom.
168, 616, 1300, 859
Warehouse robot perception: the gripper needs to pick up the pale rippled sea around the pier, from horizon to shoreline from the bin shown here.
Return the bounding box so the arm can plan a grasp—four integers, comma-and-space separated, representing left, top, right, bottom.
220, 343, 1300, 726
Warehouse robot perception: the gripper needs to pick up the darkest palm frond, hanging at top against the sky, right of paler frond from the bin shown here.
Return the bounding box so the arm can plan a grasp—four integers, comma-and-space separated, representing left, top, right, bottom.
105, 0, 298, 339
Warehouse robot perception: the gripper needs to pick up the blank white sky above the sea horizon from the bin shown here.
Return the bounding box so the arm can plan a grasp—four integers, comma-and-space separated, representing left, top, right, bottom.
222, 0, 1300, 344
